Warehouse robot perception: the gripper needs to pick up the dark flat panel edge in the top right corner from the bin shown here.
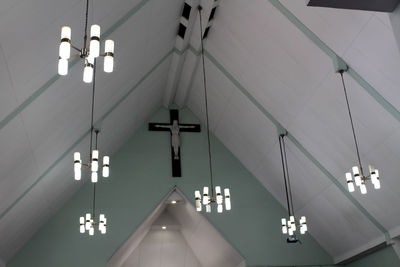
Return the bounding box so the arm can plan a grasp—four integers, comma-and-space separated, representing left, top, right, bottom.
307, 0, 399, 12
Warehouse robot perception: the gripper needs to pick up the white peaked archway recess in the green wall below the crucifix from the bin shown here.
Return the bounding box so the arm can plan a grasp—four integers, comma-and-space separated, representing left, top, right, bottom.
107, 188, 245, 267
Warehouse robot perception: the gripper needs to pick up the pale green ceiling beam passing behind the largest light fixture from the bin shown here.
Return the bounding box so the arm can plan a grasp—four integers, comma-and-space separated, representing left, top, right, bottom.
0, 0, 150, 133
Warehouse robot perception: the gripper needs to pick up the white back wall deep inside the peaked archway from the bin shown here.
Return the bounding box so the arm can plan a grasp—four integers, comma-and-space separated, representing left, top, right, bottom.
123, 229, 201, 267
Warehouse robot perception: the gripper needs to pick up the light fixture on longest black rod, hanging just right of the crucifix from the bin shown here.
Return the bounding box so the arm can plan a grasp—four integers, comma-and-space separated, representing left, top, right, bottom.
194, 6, 231, 213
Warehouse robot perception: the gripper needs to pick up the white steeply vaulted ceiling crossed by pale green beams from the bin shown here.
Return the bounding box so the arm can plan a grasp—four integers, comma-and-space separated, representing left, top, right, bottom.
0, 0, 400, 262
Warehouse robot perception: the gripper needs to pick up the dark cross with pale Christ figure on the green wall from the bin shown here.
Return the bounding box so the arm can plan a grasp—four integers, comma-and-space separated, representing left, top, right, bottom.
149, 109, 200, 177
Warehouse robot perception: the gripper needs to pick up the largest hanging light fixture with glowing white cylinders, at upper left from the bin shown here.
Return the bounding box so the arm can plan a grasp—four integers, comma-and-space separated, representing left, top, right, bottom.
58, 0, 114, 83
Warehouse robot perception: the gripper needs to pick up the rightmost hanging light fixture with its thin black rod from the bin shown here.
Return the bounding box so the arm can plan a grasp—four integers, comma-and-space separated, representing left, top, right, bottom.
339, 70, 381, 195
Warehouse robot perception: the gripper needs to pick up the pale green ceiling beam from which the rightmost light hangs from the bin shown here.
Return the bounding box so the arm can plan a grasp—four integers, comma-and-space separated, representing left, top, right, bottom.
269, 0, 400, 125
